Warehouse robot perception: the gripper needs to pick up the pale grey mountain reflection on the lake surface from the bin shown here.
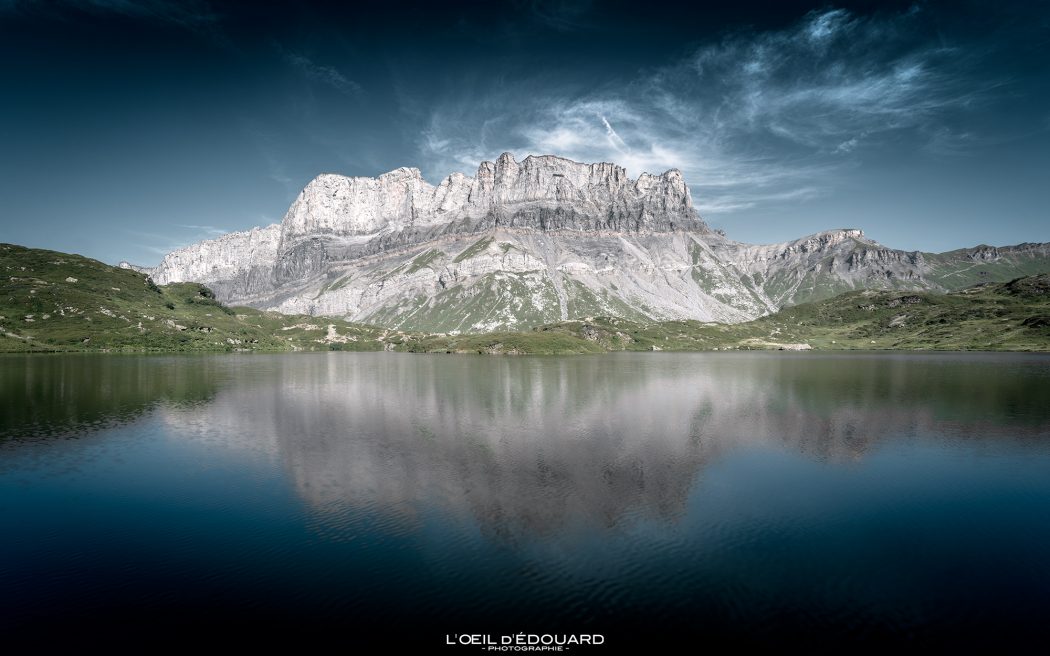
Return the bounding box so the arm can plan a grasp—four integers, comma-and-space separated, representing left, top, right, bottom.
148, 354, 1050, 539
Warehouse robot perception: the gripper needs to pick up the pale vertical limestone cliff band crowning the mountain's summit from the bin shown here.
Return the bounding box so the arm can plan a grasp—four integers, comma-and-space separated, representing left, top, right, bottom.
281, 153, 696, 242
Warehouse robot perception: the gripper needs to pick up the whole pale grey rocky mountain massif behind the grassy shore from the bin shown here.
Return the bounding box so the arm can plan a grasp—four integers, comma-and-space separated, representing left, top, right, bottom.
147, 153, 1050, 333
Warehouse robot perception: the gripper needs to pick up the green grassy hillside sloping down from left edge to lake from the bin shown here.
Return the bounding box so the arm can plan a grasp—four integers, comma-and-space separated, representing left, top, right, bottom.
0, 244, 398, 352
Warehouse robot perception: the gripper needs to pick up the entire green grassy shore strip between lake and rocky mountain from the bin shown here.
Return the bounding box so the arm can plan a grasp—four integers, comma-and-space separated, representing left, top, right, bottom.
6, 240, 1050, 354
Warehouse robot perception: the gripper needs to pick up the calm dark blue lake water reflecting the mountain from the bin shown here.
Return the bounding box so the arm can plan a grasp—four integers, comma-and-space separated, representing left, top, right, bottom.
0, 353, 1050, 654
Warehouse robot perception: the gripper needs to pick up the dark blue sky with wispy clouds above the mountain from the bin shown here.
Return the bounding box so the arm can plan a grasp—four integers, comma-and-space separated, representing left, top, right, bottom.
0, 0, 1050, 264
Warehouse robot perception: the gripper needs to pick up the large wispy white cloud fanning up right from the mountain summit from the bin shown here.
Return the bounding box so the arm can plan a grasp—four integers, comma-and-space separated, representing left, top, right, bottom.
419, 9, 996, 213
